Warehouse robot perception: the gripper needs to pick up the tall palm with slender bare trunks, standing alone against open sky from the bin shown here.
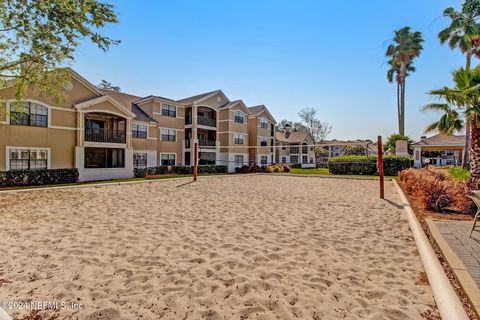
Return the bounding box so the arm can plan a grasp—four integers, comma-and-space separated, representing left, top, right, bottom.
386, 26, 424, 136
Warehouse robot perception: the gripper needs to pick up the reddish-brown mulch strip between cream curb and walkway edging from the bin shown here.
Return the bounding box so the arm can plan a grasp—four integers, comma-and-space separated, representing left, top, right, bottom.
398, 181, 480, 320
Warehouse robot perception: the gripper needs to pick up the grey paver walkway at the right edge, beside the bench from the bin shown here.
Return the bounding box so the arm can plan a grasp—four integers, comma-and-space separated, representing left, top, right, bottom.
434, 220, 480, 287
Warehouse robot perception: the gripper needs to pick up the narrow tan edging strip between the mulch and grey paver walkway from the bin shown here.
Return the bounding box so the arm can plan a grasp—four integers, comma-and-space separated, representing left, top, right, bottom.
425, 218, 480, 316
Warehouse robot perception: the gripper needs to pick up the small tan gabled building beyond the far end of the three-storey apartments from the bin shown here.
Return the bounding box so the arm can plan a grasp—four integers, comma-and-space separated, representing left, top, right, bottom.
276, 126, 316, 168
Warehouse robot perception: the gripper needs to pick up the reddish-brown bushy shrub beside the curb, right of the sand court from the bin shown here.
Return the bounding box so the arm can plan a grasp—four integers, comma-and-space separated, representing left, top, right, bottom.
400, 168, 475, 214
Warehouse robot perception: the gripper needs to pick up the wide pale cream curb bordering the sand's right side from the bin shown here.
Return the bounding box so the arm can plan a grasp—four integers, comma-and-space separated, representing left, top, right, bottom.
393, 180, 470, 320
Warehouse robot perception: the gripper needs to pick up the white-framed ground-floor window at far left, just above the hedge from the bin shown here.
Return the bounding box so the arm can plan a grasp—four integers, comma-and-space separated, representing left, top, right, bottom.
9, 149, 48, 170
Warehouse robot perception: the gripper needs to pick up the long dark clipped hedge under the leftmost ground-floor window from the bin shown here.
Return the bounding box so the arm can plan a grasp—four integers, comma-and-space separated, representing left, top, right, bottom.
0, 169, 78, 187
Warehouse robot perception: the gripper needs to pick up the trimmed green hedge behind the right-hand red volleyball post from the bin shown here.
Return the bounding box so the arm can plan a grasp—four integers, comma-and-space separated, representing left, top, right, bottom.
328, 156, 412, 176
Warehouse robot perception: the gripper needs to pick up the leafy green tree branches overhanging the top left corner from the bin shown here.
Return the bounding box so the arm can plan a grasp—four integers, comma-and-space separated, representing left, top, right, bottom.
0, 0, 119, 99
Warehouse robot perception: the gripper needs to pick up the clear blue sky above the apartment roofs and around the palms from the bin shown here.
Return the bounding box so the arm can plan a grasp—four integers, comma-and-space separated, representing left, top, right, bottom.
72, 0, 466, 139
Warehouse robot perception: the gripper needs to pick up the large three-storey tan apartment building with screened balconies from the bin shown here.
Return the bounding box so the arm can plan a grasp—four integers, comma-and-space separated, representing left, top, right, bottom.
0, 69, 275, 181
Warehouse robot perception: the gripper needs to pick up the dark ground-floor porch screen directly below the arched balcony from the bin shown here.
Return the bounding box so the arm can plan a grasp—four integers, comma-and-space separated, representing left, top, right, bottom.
85, 148, 125, 169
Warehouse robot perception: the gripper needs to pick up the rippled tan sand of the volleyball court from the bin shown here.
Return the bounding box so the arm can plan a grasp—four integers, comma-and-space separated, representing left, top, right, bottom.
0, 175, 434, 320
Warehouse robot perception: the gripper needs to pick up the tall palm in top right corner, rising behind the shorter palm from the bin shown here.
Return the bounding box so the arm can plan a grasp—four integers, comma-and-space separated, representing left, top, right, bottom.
438, 0, 480, 167
